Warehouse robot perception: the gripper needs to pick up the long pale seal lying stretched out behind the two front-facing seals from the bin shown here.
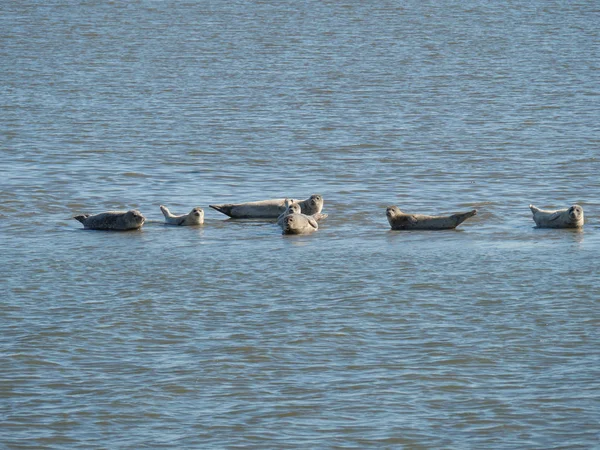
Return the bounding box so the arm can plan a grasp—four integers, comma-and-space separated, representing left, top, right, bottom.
208, 195, 323, 219
